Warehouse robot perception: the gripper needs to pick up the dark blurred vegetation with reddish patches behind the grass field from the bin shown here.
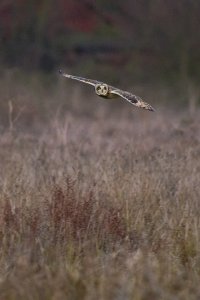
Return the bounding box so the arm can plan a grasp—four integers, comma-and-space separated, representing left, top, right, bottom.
0, 0, 200, 82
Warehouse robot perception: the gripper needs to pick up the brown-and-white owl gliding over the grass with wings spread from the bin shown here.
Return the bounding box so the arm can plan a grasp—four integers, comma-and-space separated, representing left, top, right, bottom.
59, 70, 154, 111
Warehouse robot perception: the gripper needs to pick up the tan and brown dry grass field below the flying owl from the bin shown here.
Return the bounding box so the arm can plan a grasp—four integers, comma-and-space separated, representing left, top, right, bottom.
0, 71, 200, 300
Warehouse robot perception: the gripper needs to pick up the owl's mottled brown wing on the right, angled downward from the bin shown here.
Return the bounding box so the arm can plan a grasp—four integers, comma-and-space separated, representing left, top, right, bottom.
110, 88, 155, 111
